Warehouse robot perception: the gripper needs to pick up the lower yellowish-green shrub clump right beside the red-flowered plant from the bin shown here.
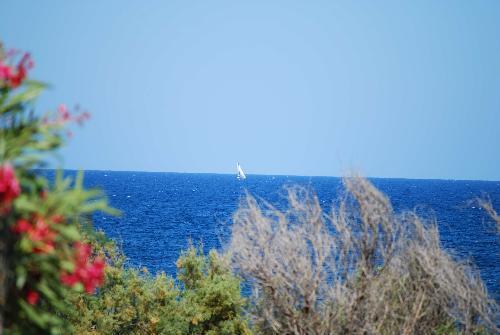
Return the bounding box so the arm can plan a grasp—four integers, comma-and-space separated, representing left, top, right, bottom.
66, 228, 178, 334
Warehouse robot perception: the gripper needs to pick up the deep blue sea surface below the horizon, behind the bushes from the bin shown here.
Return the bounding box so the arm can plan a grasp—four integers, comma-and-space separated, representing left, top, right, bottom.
45, 171, 500, 301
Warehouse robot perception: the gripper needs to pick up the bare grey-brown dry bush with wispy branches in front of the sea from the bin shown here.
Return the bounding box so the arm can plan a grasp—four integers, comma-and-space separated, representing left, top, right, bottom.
228, 177, 498, 334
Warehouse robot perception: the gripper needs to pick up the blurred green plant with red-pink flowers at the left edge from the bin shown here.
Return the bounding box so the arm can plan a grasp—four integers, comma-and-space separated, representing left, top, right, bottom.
0, 45, 114, 334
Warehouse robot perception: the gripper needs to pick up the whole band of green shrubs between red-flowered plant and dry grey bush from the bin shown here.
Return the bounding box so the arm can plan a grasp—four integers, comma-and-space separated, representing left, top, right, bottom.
67, 235, 249, 335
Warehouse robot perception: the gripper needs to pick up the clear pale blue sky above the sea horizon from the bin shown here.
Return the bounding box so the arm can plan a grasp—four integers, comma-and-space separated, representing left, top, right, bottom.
0, 0, 500, 180
